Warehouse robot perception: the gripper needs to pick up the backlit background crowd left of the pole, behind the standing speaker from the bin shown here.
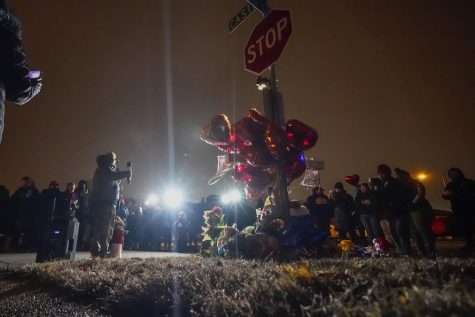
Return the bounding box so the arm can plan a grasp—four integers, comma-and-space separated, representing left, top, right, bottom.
0, 177, 238, 256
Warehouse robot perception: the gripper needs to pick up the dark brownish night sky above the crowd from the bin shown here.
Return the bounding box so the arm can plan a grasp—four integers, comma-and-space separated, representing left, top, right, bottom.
0, 0, 475, 208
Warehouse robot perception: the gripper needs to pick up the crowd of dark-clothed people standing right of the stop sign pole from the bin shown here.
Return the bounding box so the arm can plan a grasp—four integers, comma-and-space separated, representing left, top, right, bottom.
253, 164, 475, 258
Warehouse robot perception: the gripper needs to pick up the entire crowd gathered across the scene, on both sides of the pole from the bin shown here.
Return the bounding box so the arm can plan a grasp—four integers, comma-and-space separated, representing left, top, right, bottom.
0, 163, 475, 258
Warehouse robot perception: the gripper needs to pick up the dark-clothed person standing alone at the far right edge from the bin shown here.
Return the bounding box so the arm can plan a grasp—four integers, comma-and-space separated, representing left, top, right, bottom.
442, 167, 475, 249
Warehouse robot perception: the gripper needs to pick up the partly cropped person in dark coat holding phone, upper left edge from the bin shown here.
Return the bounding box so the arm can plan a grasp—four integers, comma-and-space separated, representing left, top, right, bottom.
0, 0, 41, 143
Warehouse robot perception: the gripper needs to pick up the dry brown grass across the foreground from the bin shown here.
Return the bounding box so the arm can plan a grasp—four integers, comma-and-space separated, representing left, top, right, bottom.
13, 256, 475, 316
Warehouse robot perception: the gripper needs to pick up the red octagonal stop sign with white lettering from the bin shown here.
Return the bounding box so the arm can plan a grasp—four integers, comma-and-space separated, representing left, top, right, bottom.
244, 10, 292, 75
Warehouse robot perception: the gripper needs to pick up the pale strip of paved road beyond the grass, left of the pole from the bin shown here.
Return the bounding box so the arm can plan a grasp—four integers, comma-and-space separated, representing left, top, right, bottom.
0, 251, 191, 271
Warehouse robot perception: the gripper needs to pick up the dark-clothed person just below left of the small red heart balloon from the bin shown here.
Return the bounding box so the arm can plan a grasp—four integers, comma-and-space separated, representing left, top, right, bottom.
331, 182, 356, 241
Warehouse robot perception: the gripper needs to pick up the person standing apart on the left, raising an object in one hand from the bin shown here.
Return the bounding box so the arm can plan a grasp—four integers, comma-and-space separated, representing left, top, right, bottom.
91, 152, 132, 258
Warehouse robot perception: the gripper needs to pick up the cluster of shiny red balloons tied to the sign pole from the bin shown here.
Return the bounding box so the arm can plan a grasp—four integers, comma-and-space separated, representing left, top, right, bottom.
201, 108, 318, 201
